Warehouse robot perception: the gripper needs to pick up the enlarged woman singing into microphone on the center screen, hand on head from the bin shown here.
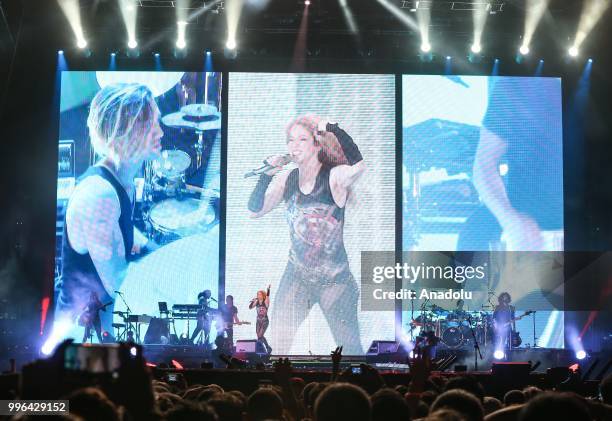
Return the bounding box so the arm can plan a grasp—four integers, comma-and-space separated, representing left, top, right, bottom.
248, 115, 365, 355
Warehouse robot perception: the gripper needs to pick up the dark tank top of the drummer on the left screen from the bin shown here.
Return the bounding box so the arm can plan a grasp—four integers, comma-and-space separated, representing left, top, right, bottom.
58, 166, 134, 310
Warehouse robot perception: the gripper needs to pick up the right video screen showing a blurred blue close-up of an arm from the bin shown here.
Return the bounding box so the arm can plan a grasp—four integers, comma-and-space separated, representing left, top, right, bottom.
402, 75, 563, 347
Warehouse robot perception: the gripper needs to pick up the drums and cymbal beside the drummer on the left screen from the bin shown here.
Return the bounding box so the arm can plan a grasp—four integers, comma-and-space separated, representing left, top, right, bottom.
143, 104, 221, 245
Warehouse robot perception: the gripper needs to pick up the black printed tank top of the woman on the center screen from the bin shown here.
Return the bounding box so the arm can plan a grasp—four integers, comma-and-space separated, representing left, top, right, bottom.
284, 165, 348, 281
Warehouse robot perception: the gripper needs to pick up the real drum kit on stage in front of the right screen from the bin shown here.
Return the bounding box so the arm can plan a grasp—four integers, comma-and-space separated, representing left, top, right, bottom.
409, 304, 493, 349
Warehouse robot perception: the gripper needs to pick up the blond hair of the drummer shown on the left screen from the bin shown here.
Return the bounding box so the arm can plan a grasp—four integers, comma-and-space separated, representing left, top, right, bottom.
87, 83, 156, 161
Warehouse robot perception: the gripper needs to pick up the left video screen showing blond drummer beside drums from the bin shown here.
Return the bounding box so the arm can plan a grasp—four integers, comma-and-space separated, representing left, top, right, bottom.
51, 71, 222, 343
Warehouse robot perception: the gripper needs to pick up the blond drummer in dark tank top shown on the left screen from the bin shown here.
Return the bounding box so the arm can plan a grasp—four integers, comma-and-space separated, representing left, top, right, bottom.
57, 84, 163, 332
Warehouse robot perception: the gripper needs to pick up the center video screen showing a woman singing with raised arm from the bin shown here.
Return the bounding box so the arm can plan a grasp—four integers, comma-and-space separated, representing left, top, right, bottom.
225, 73, 396, 355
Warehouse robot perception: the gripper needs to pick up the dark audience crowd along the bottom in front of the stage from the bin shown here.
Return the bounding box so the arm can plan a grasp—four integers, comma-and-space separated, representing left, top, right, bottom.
1, 340, 612, 421
